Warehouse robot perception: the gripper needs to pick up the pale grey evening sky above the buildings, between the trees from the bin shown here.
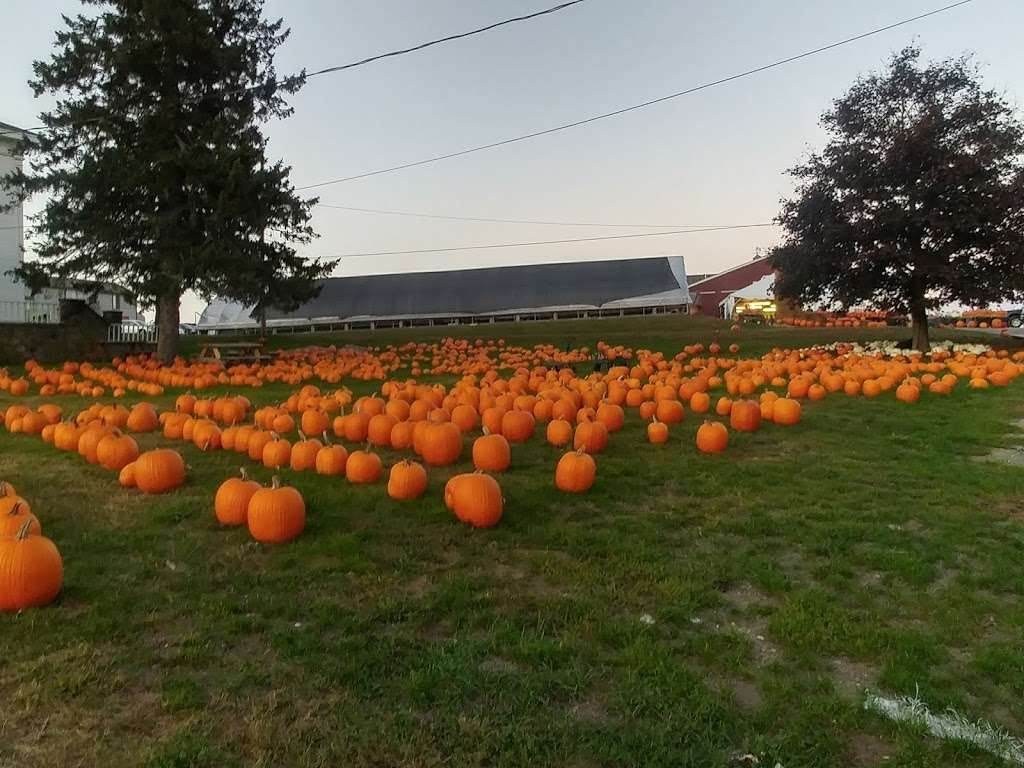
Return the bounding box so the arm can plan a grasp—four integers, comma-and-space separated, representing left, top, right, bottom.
0, 0, 1024, 321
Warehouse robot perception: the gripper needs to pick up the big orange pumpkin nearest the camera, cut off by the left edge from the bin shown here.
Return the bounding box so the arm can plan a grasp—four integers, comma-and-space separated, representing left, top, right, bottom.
0, 520, 63, 611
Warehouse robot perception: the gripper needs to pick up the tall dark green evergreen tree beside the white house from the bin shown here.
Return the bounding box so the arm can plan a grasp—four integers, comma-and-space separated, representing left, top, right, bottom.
0, 0, 330, 360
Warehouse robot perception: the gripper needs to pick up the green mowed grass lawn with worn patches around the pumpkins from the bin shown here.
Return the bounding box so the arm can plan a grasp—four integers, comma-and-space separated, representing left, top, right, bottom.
0, 317, 1024, 768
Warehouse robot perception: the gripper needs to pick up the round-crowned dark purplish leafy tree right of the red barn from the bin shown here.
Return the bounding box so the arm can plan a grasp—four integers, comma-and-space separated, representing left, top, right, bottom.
771, 46, 1024, 351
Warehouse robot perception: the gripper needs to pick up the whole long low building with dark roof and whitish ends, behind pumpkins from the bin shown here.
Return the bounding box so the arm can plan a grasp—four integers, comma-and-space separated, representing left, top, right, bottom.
199, 256, 690, 333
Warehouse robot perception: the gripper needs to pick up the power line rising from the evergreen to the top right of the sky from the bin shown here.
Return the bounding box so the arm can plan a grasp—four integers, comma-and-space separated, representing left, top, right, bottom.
296, 0, 974, 190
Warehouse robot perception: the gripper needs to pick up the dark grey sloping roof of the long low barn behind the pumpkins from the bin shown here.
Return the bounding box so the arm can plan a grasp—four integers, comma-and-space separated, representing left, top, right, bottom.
267, 256, 689, 319
